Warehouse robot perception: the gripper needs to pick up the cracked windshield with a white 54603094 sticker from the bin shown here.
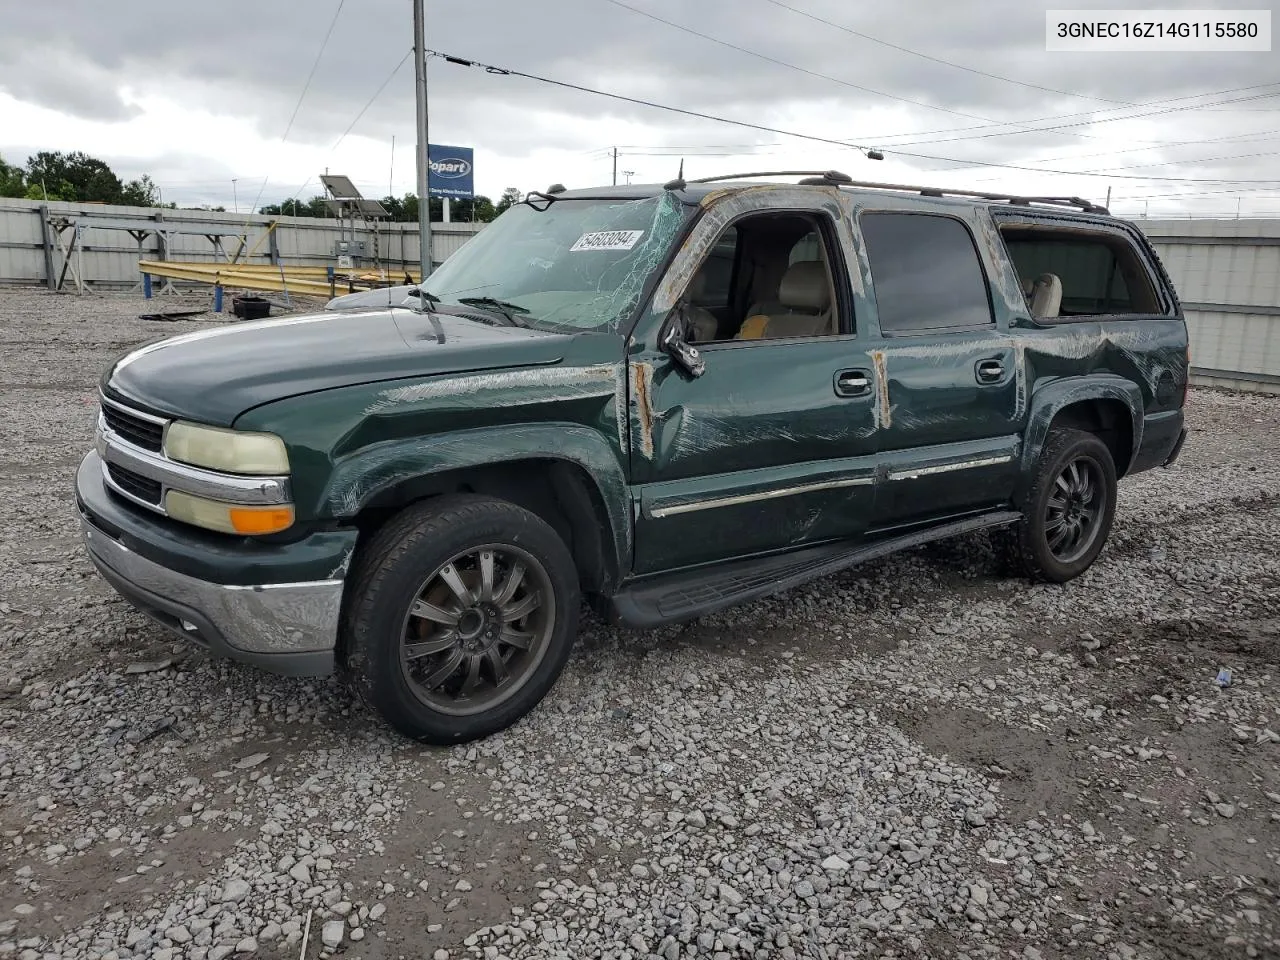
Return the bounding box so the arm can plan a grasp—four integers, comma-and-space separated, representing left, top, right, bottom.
425, 195, 689, 332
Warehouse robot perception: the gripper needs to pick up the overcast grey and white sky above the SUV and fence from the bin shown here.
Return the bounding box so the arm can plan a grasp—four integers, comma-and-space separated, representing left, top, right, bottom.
0, 0, 1280, 216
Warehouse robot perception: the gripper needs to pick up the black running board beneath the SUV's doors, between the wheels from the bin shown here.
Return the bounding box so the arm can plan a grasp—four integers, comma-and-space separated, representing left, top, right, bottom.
607, 511, 1023, 628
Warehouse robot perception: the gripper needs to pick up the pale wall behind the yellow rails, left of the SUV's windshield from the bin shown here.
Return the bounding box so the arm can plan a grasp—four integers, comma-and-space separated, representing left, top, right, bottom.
0, 197, 484, 289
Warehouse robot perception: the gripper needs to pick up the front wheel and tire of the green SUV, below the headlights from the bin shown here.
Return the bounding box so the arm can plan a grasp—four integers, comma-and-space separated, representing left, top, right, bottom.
344, 494, 580, 744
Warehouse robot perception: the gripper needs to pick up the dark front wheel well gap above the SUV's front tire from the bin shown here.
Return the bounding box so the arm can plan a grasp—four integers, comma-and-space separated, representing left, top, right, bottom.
356, 460, 618, 594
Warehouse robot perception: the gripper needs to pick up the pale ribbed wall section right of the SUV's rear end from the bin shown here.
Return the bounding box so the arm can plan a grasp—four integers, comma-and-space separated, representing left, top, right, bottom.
1137, 220, 1280, 394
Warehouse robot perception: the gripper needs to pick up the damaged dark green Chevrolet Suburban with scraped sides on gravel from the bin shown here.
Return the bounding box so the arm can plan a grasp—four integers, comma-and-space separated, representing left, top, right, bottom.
76, 172, 1188, 744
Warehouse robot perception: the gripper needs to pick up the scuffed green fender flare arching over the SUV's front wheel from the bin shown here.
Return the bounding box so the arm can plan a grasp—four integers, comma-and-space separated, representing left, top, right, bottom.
321, 421, 631, 571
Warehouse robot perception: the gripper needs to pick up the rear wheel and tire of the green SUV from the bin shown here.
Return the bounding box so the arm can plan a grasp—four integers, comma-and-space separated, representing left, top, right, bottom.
1004, 428, 1116, 584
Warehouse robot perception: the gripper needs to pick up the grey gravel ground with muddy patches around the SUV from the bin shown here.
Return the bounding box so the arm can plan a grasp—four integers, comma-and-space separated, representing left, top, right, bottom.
0, 291, 1280, 960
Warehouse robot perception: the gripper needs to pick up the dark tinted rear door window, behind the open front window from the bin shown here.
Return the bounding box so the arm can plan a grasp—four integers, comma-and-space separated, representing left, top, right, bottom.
859, 212, 993, 334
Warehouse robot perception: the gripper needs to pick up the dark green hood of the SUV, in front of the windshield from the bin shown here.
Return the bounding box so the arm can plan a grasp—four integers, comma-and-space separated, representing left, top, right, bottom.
104, 310, 564, 426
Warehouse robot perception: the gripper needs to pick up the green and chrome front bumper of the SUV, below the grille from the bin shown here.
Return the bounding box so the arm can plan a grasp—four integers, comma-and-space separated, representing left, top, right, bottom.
76, 453, 355, 676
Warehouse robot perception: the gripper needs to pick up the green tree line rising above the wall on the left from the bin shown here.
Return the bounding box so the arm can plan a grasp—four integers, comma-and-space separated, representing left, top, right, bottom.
0, 150, 524, 223
